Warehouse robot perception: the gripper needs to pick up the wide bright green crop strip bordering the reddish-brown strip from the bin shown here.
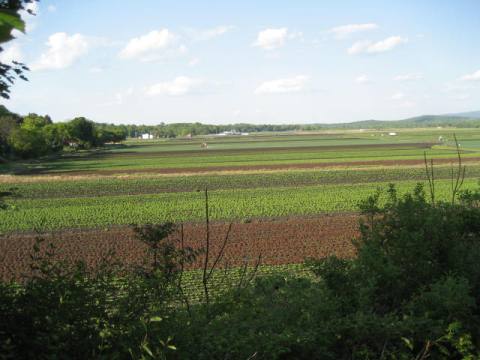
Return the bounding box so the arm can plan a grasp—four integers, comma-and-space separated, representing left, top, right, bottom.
0, 179, 477, 232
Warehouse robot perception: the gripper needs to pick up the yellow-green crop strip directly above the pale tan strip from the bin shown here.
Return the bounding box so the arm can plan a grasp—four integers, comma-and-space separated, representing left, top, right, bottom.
4, 148, 472, 173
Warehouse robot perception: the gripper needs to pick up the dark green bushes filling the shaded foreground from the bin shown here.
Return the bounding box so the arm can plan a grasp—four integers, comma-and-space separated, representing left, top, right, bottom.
0, 187, 480, 359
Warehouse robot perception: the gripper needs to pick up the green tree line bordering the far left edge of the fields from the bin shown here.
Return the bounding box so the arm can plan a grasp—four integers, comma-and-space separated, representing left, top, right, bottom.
0, 105, 300, 160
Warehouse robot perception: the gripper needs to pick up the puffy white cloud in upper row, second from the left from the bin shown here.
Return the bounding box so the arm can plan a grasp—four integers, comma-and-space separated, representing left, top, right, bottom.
120, 29, 187, 61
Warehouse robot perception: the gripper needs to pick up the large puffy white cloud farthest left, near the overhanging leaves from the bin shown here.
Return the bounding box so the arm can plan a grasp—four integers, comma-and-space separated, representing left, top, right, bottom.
32, 32, 89, 71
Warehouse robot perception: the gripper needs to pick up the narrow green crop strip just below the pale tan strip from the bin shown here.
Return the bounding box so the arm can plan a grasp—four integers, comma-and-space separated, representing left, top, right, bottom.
0, 165, 480, 199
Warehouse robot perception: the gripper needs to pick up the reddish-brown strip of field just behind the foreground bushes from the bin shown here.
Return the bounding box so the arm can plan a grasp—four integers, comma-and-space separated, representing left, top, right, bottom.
0, 214, 358, 280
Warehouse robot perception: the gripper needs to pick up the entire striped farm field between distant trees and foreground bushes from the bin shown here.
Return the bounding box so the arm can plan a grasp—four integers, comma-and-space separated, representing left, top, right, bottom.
0, 129, 480, 278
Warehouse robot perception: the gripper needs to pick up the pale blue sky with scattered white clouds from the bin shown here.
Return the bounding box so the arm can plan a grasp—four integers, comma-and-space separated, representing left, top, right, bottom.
0, 0, 480, 124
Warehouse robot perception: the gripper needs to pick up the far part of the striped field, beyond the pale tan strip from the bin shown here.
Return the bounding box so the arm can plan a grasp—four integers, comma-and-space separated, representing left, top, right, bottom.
0, 130, 480, 175
